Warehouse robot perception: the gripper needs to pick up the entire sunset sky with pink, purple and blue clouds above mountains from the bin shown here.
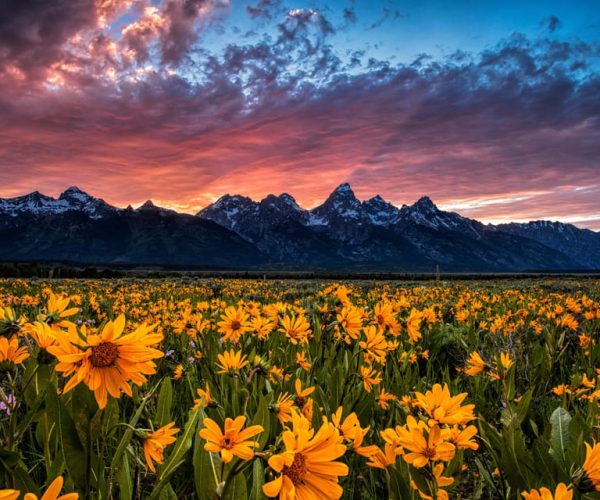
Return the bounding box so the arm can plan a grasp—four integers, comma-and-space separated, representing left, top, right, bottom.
0, 0, 600, 230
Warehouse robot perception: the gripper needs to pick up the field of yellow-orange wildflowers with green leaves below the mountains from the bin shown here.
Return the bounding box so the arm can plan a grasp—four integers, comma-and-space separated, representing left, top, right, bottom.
0, 278, 600, 500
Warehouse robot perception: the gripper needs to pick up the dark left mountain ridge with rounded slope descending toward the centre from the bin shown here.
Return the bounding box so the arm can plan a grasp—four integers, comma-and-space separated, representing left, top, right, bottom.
0, 187, 266, 268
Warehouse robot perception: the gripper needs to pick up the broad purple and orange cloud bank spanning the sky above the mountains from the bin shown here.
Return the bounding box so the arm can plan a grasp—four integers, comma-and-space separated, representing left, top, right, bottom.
0, 12, 600, 227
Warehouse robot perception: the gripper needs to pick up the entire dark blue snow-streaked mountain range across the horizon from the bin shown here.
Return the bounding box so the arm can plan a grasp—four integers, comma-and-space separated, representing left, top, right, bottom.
0, 183, 600, 272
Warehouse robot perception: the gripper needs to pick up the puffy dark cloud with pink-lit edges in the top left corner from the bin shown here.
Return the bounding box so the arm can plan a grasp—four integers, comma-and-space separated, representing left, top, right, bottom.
0, 0, 227, 88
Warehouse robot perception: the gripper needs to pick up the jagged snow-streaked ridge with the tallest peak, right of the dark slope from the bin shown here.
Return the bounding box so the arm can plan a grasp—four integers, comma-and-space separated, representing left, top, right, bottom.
198, 183, 600, 271
